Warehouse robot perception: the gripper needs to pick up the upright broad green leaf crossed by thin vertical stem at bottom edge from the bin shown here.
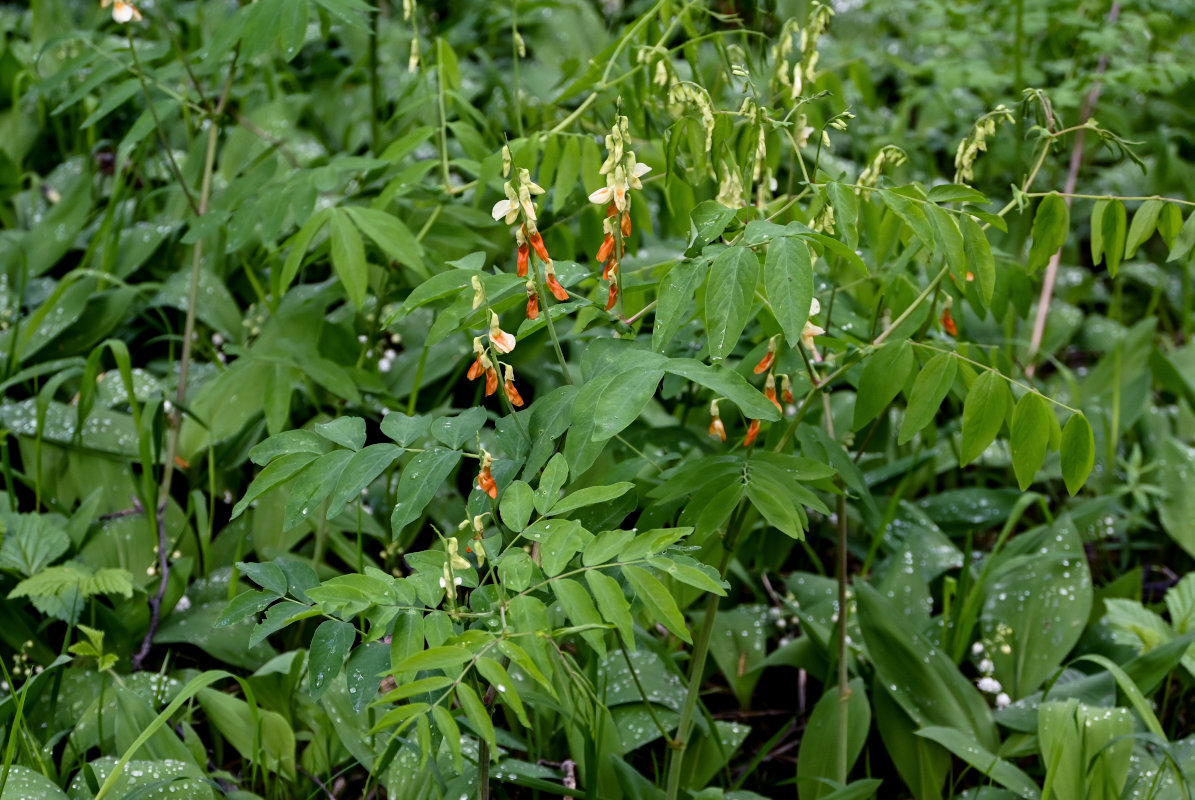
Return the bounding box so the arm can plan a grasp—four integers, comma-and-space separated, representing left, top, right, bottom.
797, 678, 871, 800
